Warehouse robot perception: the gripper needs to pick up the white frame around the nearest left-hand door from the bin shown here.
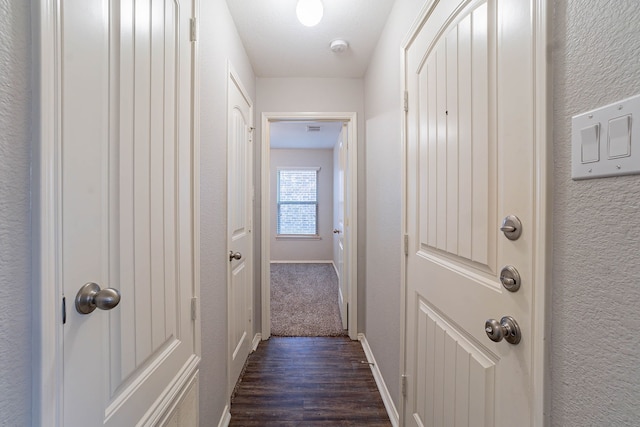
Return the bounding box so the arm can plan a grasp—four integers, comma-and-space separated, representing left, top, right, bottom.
31, 0, 202, 426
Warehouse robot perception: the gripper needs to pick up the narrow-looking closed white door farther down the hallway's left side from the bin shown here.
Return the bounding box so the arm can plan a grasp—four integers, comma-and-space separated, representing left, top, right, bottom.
227, 71, 253, 392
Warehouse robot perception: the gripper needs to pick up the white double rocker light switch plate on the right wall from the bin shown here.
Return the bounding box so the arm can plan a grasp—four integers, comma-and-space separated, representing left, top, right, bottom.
571, 95, 640, 179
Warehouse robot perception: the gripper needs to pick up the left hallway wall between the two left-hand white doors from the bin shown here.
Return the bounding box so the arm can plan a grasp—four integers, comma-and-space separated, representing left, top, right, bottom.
199, 0, 255, 426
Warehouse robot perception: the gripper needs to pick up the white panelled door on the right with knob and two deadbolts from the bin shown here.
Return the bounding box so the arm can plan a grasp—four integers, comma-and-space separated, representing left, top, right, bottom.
404, 0, 544, 427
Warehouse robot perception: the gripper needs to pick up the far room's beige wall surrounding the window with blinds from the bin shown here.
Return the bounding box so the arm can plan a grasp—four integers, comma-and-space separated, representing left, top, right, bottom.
270, 148, 333, 262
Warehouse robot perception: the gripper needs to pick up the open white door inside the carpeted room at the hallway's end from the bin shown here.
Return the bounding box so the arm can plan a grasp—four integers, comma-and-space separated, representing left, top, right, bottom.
333, 124, 349, 329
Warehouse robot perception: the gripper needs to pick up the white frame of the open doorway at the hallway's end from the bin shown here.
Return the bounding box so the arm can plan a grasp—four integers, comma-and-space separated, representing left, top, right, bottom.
260, 112, 358, 340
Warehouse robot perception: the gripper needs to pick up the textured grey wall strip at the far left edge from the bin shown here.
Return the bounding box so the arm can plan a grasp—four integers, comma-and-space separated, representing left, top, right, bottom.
0, 0, 31, 426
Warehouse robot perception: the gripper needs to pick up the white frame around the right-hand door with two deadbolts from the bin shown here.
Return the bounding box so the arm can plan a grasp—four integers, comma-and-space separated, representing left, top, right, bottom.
399, 0, 553, 427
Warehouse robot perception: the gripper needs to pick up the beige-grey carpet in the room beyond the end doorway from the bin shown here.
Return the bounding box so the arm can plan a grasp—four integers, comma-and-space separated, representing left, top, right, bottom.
271, 264, 347, 337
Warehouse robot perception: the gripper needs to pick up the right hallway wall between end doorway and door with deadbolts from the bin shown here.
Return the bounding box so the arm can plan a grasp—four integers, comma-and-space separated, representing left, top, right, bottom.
365, 0, 425, 410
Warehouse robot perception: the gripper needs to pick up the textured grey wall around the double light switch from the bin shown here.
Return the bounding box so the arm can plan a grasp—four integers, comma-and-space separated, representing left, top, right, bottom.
551, 0, 640, 427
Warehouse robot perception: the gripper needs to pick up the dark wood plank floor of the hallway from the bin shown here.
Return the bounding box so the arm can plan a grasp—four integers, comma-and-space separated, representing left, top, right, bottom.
229, 337, 391, 427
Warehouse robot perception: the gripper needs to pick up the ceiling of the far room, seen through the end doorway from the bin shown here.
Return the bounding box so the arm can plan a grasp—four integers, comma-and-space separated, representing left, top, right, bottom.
269, 121, 342, 149
